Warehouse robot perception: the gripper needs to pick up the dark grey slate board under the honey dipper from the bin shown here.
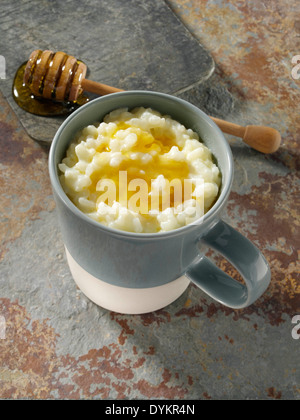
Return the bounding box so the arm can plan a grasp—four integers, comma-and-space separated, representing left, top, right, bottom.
0, 0, 214, 142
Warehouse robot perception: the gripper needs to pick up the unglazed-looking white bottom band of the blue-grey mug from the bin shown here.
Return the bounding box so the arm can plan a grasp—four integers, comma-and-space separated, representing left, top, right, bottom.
66, 248, 190, 315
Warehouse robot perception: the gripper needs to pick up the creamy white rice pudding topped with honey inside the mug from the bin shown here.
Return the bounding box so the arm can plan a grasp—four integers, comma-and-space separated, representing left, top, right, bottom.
58, 107, 221, 233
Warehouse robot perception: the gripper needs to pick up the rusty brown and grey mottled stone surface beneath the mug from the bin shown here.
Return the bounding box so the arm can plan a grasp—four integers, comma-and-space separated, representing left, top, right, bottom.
0, 0, 300, 400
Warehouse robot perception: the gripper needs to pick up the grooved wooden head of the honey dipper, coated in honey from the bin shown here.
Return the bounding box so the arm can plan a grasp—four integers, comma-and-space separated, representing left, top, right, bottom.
24, 50, 87, 102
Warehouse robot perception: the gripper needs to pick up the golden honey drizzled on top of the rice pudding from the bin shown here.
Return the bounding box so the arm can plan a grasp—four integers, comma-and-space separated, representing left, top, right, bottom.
88, 122, 190, 213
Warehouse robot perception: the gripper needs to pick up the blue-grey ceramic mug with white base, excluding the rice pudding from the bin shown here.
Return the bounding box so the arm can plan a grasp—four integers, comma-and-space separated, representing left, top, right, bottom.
49, 91, 271, 314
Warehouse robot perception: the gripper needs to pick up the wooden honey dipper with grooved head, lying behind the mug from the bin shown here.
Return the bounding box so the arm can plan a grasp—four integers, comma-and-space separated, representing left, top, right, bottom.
24, 50, 281, 153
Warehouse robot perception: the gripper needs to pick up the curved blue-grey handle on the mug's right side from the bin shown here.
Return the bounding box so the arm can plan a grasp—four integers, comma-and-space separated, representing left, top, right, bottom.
186, 220, 271, 309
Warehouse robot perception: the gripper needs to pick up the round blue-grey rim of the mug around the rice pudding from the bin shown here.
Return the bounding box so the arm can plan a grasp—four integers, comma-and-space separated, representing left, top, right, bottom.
48, 90, 233, 240
